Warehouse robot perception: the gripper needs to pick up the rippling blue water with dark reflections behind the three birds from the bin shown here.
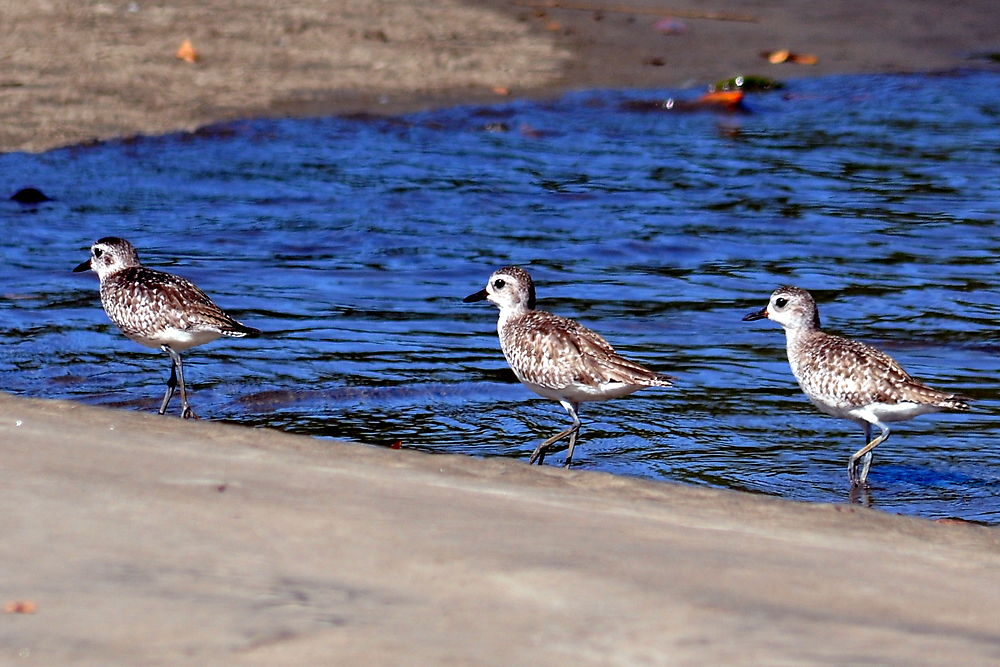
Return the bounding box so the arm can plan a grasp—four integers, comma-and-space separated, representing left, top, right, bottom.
0, 73, 1000, 524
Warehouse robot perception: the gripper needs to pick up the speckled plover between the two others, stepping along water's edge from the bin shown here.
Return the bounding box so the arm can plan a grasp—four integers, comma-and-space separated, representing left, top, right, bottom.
464, 266, 671, 467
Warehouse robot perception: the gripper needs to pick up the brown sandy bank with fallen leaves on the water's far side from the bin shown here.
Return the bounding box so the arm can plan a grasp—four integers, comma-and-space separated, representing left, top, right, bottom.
0, 0, 1000, 152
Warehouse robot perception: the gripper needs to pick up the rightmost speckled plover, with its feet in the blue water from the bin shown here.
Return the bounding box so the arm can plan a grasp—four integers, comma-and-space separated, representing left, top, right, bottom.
743, 286, 970, 487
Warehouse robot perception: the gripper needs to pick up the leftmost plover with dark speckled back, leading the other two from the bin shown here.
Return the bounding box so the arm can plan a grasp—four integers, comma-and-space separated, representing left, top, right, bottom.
73, 236, 261, 419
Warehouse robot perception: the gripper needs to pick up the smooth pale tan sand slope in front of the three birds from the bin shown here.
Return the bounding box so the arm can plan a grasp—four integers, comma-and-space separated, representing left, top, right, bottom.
0, 394, 1000, 665
